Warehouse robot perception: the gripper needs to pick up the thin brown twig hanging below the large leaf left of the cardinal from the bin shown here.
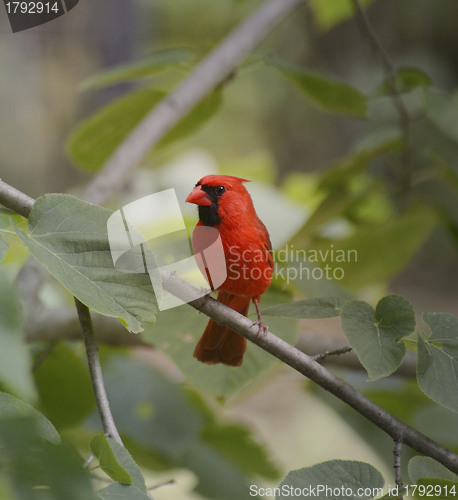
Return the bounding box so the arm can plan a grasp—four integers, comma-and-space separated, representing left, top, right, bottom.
75, 297, 123, 445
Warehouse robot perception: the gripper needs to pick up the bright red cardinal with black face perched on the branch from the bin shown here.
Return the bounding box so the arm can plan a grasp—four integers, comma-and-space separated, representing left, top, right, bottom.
186, 175, 273, 366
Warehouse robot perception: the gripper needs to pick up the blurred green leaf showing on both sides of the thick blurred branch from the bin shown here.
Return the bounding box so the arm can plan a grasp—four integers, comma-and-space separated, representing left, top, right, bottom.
67, 88, 222, 172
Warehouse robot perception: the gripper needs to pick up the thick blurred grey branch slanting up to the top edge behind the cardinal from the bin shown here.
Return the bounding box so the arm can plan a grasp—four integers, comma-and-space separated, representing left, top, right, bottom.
83, 0, 304, 205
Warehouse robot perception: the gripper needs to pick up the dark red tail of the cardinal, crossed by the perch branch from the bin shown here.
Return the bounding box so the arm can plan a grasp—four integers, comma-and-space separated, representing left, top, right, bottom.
194, 292, 250, 366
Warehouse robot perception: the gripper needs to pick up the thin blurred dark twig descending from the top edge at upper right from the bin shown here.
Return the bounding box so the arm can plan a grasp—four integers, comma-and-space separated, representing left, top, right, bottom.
352, 0, 413, 191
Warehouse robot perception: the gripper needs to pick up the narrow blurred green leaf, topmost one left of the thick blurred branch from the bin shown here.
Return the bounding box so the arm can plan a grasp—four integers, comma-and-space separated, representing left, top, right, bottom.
81, 49, 194, 90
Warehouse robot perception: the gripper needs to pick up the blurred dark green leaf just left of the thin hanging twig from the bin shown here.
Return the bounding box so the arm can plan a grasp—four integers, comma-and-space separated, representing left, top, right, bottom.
34, 343, 95, 429
